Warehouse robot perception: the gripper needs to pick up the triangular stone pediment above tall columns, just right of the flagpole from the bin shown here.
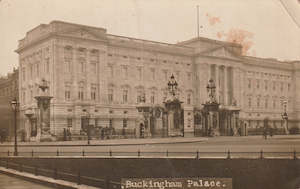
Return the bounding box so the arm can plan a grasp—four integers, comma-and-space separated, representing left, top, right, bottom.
201, 46, 241, 60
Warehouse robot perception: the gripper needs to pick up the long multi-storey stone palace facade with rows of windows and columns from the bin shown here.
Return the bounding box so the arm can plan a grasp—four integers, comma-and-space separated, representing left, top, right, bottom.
16, 21, 300, 142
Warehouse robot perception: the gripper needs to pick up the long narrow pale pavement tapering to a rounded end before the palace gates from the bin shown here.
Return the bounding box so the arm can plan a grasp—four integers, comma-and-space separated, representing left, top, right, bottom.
0, 137, 208, 147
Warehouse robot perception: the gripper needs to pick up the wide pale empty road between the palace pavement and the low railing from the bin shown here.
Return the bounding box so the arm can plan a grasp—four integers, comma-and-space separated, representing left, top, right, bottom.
0, 136, 300, 158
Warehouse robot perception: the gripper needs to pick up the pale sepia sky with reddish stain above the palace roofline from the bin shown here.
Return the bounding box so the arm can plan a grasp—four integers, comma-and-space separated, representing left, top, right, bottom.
0, 0, 300, 75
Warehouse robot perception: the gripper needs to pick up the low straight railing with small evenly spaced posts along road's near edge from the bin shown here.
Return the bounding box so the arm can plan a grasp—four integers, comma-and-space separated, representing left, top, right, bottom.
0, 149, 300, 159
